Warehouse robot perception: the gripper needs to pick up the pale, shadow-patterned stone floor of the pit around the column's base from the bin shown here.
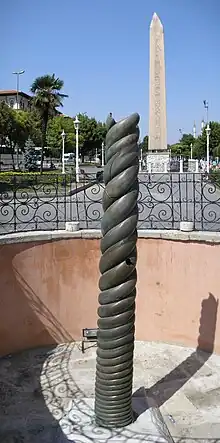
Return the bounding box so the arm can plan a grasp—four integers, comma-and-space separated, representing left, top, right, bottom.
0, 342, 220, 443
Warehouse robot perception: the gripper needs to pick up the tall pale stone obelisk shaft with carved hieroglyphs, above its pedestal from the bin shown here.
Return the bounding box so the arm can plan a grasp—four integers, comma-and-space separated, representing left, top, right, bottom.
149, 13, 167, 151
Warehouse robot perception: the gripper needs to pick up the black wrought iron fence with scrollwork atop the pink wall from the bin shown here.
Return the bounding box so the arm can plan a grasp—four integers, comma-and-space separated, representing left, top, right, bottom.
0, 173, 220, 234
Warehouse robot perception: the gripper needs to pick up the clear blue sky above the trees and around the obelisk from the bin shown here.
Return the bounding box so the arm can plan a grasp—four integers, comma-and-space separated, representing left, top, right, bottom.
0, 0, 220, 143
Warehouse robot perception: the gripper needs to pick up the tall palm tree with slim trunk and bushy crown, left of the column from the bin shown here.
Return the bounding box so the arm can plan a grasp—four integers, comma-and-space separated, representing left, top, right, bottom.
31, 74, 68, 173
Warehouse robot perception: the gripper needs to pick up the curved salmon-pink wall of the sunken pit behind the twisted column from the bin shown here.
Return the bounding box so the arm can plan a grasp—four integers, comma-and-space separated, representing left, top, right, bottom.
0, 238, 220, 355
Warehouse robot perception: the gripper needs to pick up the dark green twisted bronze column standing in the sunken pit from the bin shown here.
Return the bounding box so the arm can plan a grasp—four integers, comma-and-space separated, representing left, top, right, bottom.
95, 114, 139, 427
